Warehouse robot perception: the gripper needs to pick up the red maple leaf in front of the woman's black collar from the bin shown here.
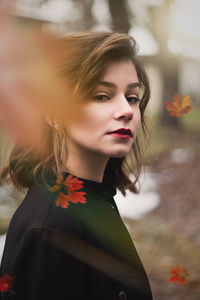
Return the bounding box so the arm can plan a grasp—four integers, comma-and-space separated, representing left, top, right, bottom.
49, 174, 86, 208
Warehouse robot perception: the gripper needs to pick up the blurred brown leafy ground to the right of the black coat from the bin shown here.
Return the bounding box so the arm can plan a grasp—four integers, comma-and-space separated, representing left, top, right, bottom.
124, 150, 200, 300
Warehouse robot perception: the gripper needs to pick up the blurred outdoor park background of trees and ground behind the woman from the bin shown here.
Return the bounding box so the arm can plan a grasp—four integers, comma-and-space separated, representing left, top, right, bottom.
0, 0, 200, 300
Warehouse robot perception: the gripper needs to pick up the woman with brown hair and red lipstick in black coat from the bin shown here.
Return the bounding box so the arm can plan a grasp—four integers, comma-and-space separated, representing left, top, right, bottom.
1, 32, 152, 300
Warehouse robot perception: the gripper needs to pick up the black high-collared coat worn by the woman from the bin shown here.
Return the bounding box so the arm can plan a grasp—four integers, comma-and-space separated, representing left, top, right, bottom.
0, 173, 152, 300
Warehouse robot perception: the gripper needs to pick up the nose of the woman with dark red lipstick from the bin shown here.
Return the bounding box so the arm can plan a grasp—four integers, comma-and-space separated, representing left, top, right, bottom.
114, 96, 134, 120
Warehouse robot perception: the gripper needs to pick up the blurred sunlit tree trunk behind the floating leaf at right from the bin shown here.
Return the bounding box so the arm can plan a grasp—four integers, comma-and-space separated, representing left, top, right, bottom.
150, 0, 180, 128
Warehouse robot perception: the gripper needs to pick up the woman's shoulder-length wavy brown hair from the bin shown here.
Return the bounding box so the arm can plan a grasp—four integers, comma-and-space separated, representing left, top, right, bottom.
1, 31, 150, 195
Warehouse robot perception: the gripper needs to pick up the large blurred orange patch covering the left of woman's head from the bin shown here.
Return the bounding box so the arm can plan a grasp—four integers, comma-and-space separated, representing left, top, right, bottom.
0, 3, 77, 156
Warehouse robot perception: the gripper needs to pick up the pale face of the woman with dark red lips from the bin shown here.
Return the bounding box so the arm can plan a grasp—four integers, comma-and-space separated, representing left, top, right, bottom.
68, 59, 141, 157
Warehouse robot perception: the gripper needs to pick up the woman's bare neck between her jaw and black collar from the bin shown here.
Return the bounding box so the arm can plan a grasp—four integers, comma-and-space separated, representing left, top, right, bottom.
66, 145, 109, 182
